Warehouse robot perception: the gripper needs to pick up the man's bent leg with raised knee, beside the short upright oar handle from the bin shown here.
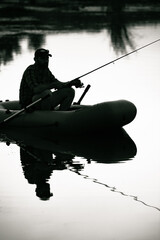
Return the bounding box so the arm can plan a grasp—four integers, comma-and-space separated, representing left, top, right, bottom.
52, 88, 75, 111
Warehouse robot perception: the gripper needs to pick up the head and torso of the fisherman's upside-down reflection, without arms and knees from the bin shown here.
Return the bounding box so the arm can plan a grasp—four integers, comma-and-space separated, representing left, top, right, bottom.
20, 147, 54, 200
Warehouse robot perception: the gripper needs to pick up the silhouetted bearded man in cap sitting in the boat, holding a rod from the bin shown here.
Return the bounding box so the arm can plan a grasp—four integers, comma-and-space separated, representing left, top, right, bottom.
19, 48, 83, 111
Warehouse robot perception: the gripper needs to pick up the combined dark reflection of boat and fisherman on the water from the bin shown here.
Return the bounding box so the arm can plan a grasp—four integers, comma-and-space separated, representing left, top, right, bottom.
0, 128, 137, 200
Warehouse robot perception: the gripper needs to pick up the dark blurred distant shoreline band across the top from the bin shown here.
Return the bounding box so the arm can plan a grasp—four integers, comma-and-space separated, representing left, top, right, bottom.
0, 4, 160, 35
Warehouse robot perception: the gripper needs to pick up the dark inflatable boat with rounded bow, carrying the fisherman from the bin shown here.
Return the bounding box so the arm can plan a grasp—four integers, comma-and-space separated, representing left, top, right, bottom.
0, 100, 137, 135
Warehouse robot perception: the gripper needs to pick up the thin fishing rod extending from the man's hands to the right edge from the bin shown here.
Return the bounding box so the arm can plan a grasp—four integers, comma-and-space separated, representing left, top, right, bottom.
75, 38, 160, 79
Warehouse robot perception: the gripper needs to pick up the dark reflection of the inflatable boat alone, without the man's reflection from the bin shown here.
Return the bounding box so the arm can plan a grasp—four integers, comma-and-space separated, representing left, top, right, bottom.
1, 125, 137, 163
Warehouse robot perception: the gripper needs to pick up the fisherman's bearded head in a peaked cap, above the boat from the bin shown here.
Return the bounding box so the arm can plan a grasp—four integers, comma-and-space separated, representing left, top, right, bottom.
34, 48, 52, 67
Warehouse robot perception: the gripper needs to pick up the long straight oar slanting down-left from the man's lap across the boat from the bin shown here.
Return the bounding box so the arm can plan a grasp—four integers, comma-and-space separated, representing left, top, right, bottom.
0, 95, 49, 126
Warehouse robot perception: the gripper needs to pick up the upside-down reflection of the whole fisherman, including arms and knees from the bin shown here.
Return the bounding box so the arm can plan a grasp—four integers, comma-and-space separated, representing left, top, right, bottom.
20, 147, 74, 200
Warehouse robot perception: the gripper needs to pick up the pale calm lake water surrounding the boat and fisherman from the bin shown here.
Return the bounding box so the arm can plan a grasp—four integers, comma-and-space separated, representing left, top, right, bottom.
0, 16, 160, 240
